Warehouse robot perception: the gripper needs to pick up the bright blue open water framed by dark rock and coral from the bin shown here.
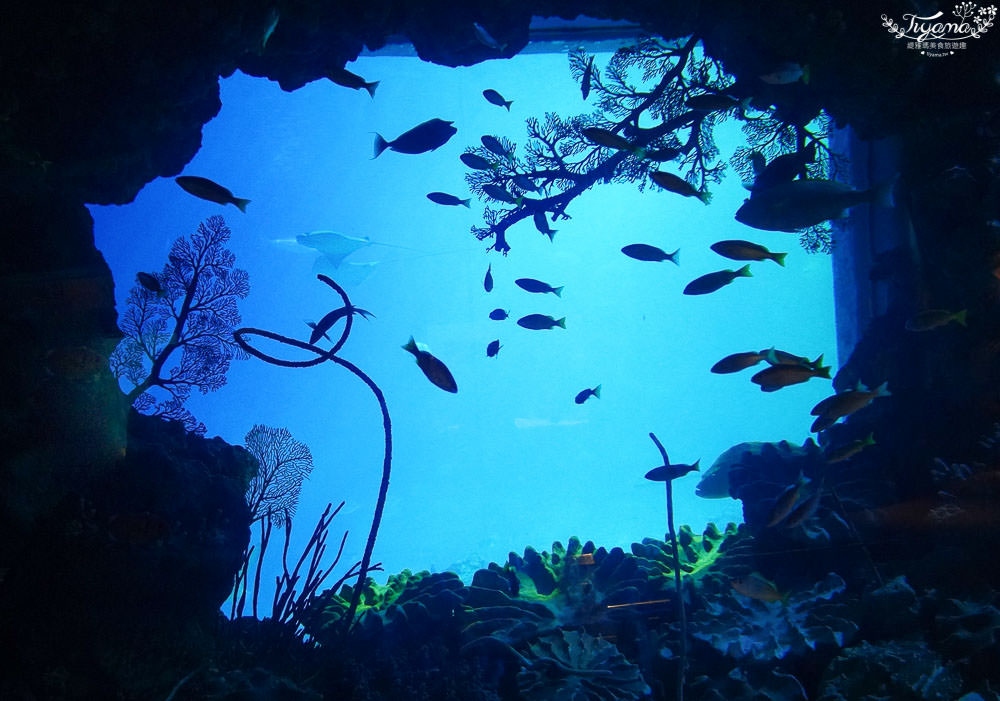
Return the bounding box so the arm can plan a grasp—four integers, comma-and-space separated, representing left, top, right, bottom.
92, 54, 837, 598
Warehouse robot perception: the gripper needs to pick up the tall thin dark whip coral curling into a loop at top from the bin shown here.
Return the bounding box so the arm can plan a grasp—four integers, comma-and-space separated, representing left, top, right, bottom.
233, 275, 392, 627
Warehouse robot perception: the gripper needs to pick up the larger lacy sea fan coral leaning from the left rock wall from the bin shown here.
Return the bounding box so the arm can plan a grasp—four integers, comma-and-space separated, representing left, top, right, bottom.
110, 216, 250, 433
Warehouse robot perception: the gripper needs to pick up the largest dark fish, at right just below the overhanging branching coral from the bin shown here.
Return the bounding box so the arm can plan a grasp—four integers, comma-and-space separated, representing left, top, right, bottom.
736, 176, 896, 232
